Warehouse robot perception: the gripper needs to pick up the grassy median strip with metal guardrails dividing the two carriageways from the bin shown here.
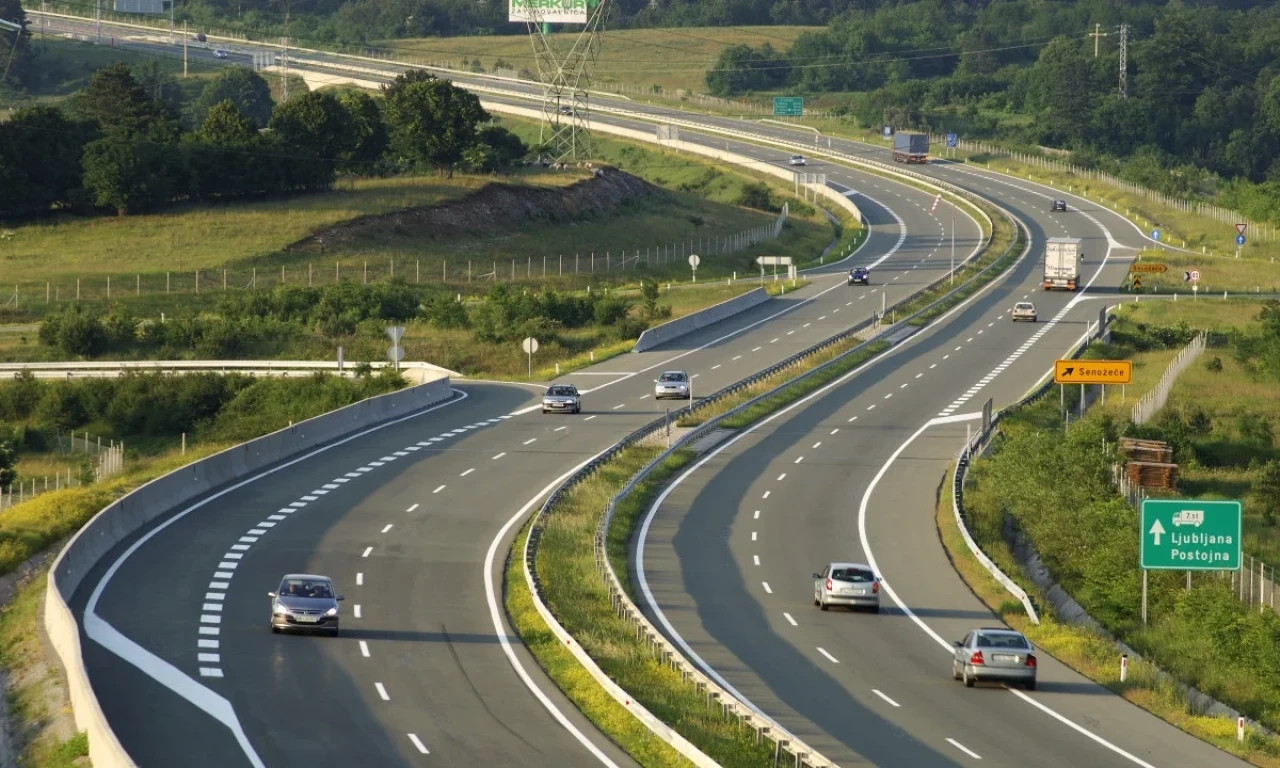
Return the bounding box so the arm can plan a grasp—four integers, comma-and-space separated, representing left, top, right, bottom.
504, 197, 1027, 767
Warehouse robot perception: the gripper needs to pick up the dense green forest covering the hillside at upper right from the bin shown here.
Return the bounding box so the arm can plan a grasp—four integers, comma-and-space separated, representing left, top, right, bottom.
707, 0, 1280, 221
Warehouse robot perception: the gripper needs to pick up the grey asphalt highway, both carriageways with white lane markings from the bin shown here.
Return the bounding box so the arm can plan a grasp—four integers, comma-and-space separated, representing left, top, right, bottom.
45, 16, 1234, 767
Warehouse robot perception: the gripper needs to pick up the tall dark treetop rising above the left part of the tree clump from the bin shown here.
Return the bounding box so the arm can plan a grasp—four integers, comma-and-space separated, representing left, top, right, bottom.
74, 61, 180, 142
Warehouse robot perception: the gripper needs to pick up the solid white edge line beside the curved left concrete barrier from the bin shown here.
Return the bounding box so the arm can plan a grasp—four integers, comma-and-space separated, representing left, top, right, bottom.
83, 389, 468, 768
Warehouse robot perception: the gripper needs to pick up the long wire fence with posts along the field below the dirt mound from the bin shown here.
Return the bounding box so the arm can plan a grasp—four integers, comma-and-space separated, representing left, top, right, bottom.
0, 205, 788, 308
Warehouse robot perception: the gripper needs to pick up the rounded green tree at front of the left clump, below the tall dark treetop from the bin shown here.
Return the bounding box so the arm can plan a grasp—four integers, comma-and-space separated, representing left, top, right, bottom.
83, 137, 183, 216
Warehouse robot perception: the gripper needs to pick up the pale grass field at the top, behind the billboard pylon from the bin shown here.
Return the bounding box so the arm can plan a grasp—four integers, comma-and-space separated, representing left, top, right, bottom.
381, 27, 820, 93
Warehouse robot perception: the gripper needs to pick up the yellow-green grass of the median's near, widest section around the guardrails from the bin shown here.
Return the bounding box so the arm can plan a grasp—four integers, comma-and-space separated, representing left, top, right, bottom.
506, 447, 773, 768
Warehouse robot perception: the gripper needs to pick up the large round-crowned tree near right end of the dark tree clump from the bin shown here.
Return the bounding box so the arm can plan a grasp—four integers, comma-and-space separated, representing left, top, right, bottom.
383, 69, 489, 177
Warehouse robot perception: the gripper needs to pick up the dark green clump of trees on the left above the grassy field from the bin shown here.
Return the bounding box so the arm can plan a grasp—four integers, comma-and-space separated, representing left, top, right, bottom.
0, 57, 529, 219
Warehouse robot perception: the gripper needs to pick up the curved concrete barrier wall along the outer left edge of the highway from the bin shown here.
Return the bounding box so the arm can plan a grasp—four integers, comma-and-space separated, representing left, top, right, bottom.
45, 375, 453, 768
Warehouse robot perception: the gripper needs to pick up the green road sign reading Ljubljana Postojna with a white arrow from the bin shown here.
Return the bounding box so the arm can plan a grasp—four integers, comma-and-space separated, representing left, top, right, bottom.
1138, 499, 1242, 571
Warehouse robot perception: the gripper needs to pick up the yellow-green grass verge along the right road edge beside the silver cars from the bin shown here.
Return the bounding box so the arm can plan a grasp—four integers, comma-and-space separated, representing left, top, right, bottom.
936, 465, 1280, 768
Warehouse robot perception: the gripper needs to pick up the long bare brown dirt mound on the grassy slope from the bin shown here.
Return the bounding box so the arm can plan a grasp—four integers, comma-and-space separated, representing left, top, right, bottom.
285, 168, 664, 252
